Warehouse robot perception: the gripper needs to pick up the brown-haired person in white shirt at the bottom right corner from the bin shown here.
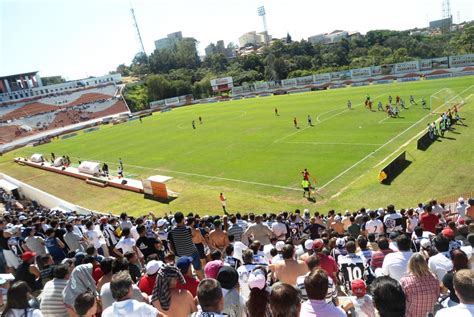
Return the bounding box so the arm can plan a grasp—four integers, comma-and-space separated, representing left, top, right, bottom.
436, 270, 474, 317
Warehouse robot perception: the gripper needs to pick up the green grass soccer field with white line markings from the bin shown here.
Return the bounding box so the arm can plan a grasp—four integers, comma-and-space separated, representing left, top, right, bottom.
0, 76, 474, 214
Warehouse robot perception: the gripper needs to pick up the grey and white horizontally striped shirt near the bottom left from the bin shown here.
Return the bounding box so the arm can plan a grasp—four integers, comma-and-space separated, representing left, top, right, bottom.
40, 278, 68, 317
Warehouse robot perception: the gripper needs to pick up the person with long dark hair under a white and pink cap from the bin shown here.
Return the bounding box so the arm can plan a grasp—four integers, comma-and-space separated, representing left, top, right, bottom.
245, 267, 271, 317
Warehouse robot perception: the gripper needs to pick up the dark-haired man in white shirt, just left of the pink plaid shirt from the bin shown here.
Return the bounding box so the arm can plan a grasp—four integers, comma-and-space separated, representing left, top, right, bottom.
382, 234, 413, 281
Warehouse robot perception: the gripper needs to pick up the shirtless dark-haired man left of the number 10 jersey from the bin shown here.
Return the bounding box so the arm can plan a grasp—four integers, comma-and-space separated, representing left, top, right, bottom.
270, 244, 308, 286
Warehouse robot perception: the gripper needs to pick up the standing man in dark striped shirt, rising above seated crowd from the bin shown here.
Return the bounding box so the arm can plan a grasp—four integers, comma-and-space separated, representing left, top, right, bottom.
168, 212, 204, 278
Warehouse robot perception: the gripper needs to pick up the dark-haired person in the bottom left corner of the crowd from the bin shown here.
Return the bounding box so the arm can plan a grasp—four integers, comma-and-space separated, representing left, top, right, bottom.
2, 281, 43, 317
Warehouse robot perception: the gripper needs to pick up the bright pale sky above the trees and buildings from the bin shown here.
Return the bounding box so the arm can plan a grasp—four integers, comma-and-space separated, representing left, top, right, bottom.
0, 0, 474, 80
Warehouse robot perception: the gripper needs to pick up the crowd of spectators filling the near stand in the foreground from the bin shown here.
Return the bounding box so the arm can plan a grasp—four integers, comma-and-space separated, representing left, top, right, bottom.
0, 186, 474, 317
